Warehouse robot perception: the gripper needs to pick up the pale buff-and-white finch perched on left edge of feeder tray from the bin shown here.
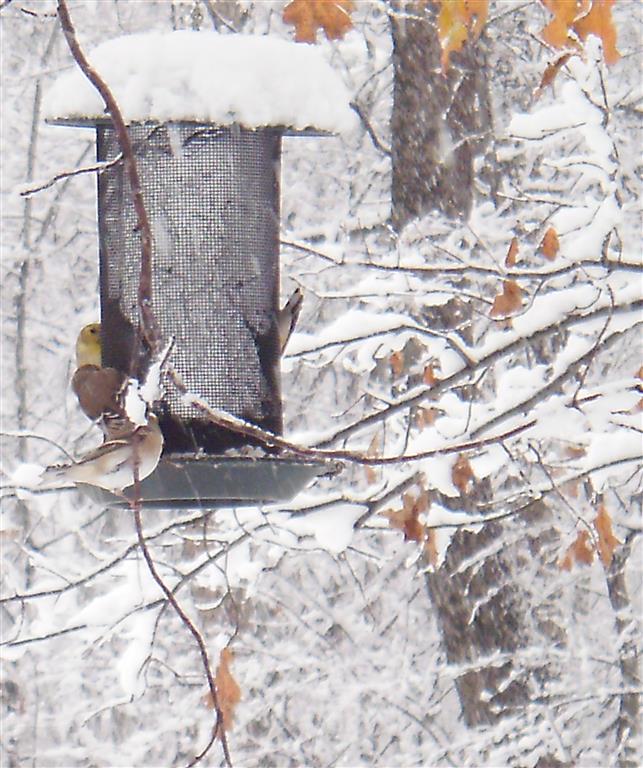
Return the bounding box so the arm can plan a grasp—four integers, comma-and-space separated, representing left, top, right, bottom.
39, 414, 163, 493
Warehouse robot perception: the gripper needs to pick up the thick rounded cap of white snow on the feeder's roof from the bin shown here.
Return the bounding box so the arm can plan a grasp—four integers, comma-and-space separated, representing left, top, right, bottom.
43, 30, 356, 132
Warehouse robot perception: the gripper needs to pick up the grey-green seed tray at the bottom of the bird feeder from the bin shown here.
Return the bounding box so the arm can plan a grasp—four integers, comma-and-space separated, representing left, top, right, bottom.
81, 456, 341, 509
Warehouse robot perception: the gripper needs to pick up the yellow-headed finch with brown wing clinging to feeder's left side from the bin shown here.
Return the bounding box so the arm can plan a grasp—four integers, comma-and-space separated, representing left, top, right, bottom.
71, 323, 134, 439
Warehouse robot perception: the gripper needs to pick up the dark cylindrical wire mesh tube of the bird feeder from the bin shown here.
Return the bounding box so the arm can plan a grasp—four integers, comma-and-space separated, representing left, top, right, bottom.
97, 124, 282, 453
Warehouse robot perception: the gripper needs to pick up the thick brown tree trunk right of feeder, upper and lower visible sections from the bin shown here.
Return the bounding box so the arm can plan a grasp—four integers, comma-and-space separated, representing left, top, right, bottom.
391, 3, 554, 736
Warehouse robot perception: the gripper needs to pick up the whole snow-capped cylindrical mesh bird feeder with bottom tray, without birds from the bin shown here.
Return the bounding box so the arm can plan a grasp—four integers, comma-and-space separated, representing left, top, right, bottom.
44, 31, 354, 507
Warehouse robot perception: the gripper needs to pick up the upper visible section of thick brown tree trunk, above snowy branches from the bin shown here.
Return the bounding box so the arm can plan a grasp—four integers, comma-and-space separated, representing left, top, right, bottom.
391, 3, 491, 231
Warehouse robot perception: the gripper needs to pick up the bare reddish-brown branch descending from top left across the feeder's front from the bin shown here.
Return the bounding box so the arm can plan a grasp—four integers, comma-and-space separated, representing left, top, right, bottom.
58, 0, 160, 353
